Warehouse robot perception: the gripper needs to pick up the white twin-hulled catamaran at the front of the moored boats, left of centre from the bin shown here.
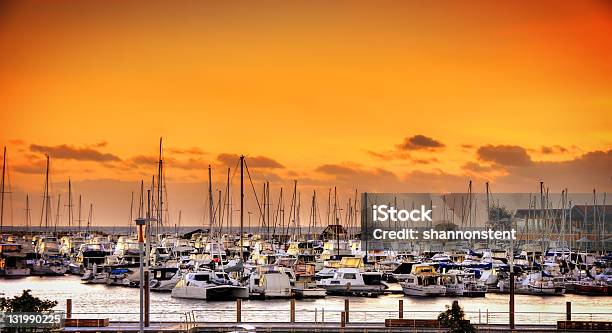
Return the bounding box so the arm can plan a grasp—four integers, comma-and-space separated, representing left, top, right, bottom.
171, 271, 249, 300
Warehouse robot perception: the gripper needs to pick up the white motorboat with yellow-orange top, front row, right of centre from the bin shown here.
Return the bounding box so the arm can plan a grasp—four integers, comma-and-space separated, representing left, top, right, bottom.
400, 264, 446, 296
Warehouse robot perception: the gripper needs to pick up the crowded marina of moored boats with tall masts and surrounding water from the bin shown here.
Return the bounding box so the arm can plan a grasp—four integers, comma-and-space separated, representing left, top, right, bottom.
0, 147, 612, 331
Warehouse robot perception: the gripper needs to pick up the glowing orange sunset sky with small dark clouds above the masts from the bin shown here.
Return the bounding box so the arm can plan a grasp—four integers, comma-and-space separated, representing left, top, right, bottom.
0, 1, 612, 225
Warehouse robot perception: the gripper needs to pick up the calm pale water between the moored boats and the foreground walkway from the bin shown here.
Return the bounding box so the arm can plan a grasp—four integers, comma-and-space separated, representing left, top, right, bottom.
0, 276, 612, 323
